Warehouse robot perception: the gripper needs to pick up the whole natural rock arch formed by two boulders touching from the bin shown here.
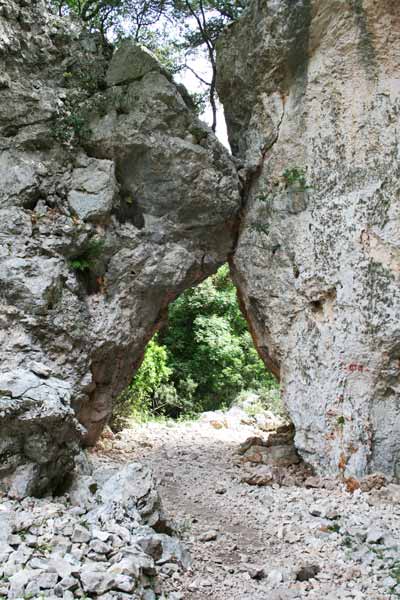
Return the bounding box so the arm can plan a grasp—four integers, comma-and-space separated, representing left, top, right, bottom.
0, 0, 400, 494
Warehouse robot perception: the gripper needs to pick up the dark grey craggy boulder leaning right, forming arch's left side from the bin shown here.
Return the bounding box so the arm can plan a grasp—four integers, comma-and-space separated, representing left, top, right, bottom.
0, 0, 240, 496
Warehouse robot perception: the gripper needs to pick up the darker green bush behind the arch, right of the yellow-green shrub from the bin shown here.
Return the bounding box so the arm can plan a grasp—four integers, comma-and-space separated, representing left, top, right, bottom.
161, 266, 272, 410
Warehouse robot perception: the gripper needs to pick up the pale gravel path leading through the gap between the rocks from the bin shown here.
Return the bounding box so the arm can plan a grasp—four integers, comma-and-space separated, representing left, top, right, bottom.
96, 420, 400, 600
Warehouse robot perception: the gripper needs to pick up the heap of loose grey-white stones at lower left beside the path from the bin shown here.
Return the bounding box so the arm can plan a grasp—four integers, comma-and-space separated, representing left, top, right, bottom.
0, 463, 189, 600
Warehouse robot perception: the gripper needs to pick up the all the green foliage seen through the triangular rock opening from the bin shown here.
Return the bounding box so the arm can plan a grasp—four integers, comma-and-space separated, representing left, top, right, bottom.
117, 266, 277, 418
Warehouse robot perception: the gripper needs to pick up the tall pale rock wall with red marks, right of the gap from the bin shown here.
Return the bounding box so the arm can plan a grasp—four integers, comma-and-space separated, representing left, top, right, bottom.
218, 0, 400, 478
